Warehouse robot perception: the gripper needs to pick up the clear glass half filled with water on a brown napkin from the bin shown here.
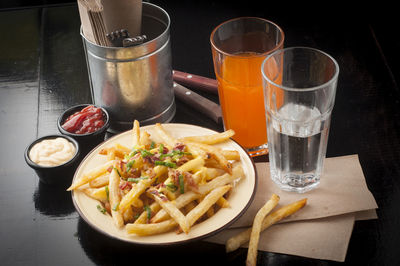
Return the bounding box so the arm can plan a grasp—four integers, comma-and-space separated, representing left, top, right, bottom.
261, 47, 339, 193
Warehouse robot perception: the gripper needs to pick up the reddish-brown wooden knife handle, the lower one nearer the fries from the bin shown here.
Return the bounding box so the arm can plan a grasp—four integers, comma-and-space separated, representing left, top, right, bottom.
173, 82, 222, 124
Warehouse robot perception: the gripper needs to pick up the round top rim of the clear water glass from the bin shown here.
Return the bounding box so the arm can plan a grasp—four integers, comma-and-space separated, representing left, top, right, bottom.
261, 46, 339, 91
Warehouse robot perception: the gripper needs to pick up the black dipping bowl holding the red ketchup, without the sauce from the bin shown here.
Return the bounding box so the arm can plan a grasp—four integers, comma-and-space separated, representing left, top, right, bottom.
57, 104, 110, 157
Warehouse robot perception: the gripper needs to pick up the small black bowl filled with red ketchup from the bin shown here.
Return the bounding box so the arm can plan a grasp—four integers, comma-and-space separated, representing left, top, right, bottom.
57, 104, 110, 156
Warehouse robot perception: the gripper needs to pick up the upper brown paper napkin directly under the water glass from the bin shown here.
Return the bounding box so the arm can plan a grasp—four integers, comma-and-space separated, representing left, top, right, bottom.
232, 155, 378, 227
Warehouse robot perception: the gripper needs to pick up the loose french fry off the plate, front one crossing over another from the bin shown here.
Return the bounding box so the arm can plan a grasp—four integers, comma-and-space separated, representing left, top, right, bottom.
246, 194, 279, 266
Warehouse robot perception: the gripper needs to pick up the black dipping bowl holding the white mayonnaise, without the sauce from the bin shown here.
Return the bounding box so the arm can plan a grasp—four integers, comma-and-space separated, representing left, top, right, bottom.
24, 135, 80, 187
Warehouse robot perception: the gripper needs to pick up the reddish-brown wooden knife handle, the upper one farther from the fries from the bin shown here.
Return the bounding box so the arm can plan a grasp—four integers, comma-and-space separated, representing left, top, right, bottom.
172, 70, 218, 94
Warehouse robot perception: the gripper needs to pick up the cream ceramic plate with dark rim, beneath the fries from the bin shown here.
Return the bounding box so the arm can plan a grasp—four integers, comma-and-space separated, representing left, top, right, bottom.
72, 124, 257, 245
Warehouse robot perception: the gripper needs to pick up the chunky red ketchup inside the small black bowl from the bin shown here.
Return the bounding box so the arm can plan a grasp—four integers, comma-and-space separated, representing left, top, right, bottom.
62, 105, 105, 134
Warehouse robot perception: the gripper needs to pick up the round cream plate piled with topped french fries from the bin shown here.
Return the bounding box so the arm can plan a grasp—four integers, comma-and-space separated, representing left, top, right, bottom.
67, 120, 257, 245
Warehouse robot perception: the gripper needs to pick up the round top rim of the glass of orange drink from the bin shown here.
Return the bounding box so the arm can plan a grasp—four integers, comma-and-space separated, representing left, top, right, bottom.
210, 17, 285, 58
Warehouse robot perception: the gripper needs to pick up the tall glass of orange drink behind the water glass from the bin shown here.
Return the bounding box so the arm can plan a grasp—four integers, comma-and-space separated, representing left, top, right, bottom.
210, 17, 284, 156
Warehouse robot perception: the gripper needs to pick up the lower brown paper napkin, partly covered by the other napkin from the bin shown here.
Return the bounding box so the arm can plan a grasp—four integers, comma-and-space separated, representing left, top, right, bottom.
206, 213, 354, 262
